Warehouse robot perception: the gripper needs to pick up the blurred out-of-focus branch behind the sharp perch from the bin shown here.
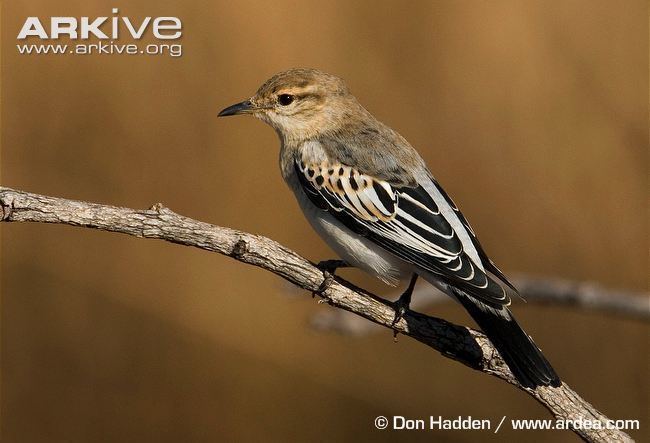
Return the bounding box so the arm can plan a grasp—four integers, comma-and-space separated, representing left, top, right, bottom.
311, 275, 650, 336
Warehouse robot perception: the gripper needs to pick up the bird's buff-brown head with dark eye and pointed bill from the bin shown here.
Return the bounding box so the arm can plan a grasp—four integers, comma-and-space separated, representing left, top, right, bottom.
219, 68, 360, 140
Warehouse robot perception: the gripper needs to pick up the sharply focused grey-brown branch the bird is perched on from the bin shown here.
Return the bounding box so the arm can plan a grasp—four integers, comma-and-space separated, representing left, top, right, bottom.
0, 187, 631, 442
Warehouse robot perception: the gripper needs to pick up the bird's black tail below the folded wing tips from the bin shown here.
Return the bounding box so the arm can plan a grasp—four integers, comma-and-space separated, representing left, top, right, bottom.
458, 296, 562, 388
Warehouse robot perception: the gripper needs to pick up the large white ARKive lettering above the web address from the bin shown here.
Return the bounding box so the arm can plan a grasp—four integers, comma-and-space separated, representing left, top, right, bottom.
17, 8, 183, 40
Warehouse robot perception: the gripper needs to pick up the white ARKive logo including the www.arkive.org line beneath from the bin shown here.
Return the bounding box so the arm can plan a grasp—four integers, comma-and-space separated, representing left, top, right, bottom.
16, 8, 183, 57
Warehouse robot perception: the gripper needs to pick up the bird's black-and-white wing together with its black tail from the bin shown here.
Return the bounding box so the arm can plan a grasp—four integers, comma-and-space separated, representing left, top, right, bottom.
295, 161, 561, 388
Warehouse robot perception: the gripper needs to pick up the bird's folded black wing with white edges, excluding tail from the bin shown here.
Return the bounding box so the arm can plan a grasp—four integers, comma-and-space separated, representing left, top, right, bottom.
294, 160, 510, 309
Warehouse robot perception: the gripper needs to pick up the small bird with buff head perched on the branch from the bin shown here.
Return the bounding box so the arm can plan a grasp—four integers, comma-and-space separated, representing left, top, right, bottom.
219, 69, 560, 388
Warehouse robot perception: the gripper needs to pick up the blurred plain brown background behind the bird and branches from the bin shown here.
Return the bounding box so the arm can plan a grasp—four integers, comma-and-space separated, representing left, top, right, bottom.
1, 0, 650, 442
